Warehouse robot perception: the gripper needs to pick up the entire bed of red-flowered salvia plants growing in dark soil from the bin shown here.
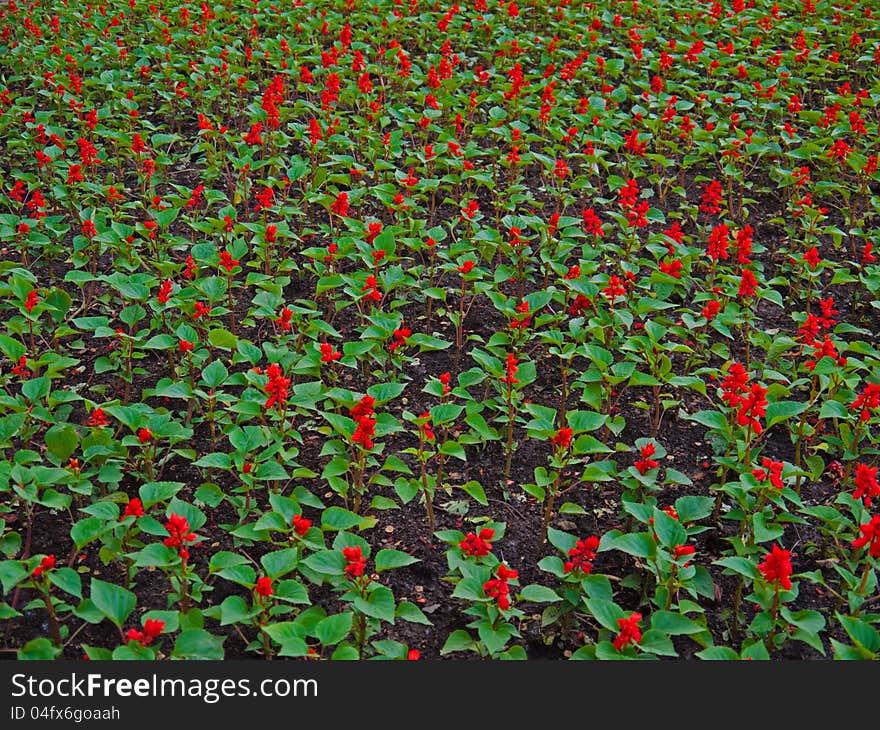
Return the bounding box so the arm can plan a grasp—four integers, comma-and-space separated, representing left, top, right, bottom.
0, 0, 880, 660
